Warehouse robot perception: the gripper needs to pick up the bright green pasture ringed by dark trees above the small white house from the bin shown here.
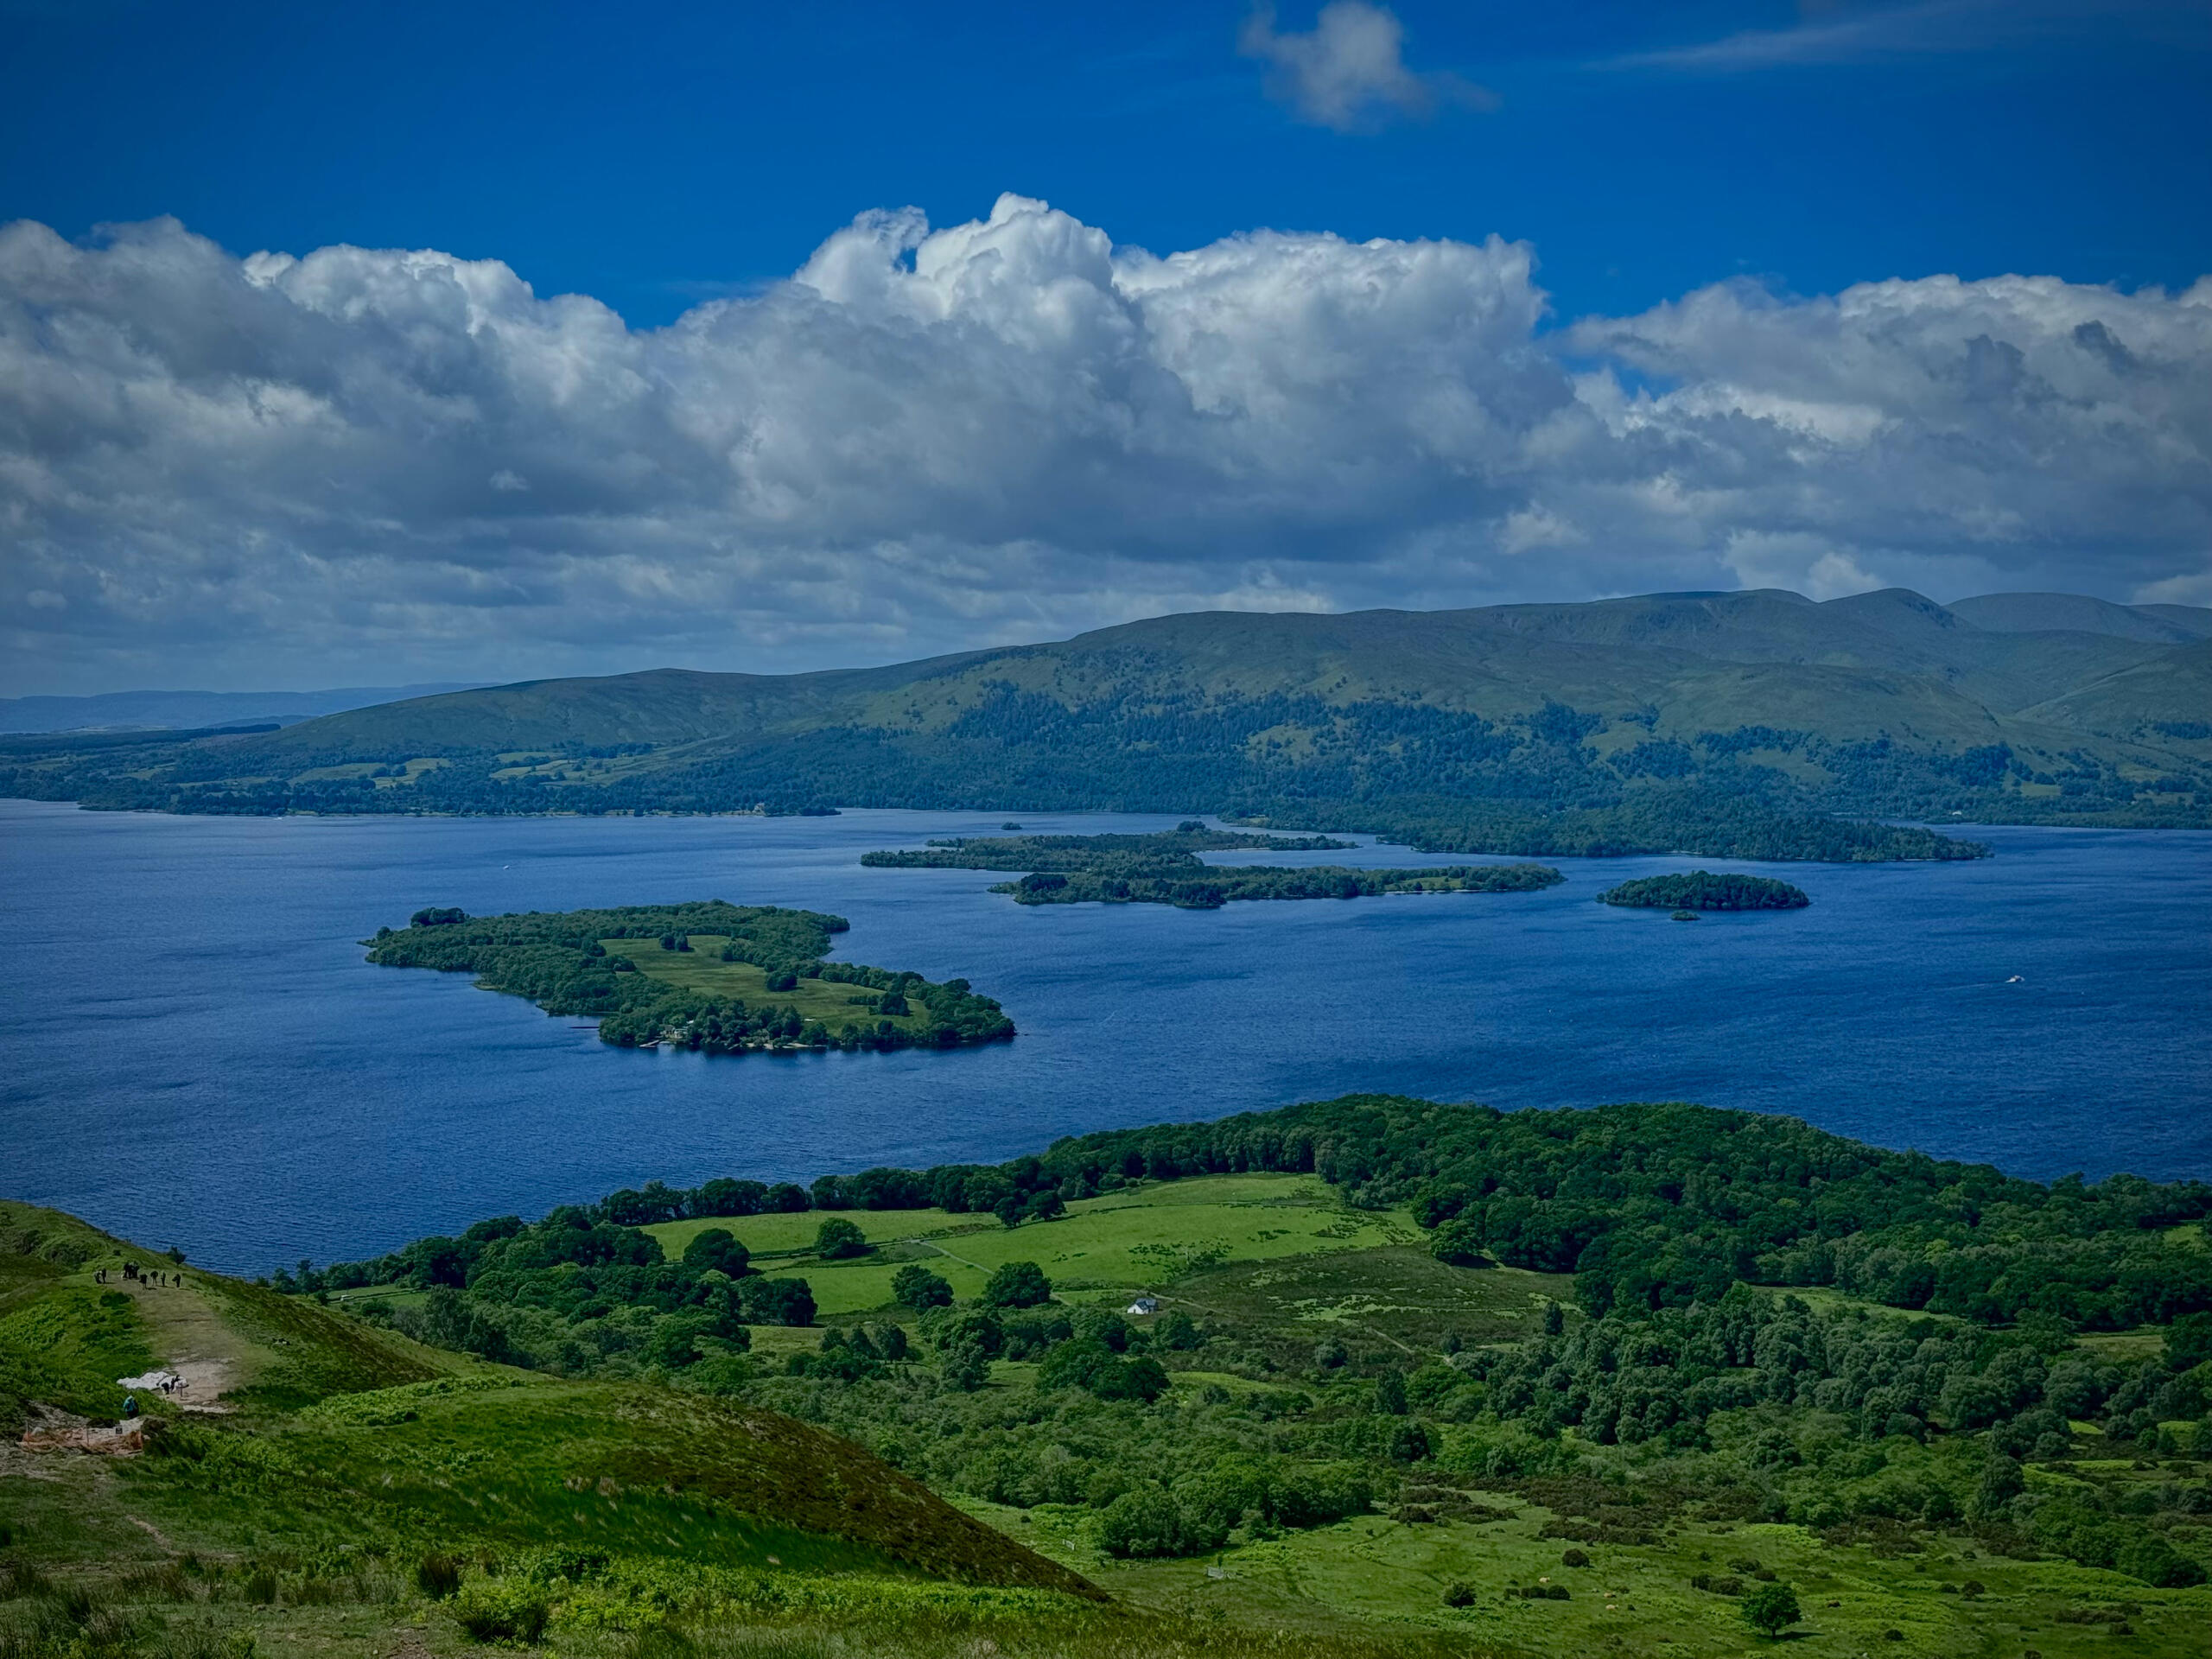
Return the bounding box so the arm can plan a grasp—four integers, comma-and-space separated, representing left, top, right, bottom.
646, 1174, 1415, 1316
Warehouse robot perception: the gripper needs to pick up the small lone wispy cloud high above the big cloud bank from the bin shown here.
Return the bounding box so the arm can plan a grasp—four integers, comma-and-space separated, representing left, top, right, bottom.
1236, 0, 1497, 133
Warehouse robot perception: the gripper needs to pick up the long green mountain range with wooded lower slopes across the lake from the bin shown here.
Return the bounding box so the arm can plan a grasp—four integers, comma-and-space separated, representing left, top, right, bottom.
0, 588, 2212, 856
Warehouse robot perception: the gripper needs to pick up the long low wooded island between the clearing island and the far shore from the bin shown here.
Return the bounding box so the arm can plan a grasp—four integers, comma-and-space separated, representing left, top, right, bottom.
861, 821, 1561, 909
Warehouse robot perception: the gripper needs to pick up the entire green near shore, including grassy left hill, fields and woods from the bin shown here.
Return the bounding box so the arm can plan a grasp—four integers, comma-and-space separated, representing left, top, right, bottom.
17, 1095, 2212, 1659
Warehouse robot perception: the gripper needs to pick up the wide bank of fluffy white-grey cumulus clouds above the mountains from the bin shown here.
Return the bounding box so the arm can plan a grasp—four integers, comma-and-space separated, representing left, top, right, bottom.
0, 197, 2212, 690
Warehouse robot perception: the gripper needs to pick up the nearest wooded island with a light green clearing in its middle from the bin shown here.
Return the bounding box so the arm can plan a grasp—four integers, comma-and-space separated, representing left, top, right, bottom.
363, 898, 1013, 1055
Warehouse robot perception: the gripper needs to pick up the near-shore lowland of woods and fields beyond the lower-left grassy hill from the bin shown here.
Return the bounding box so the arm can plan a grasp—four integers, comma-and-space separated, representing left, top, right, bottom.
246, 1095, 2212, 1659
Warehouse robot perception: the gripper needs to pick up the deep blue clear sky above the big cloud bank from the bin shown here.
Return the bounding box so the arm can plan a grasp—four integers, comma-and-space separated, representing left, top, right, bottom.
17, 0, 2212, 325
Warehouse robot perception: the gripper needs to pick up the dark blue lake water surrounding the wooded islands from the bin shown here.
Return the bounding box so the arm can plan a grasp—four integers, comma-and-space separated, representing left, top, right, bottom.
0, 801, 2212, 1272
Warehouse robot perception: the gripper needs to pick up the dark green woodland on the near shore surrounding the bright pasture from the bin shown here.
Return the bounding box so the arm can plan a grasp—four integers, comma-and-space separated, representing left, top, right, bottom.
279, 1097, 2212, 1595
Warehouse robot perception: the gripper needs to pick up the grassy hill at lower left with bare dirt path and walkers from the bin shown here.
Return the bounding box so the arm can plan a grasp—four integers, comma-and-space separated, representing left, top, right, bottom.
0, 1204, 1132, 1659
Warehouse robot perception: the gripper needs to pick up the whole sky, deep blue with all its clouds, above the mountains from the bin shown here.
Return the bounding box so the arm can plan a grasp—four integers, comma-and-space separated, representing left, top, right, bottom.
0, 0, 2212, 695
